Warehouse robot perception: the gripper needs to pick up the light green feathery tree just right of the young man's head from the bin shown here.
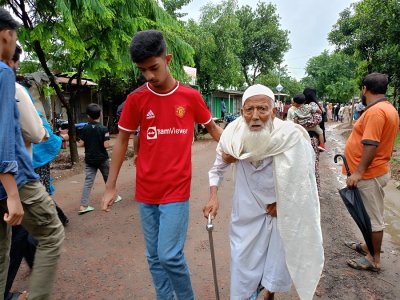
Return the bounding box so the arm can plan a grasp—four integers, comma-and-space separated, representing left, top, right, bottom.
186, 0, 243, 93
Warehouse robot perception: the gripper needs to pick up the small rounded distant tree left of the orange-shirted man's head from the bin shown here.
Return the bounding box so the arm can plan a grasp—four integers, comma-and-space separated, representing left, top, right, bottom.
303, 50, 358, 102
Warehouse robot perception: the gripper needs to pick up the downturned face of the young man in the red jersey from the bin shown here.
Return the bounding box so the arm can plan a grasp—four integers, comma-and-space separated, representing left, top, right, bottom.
136, 54, 172, 89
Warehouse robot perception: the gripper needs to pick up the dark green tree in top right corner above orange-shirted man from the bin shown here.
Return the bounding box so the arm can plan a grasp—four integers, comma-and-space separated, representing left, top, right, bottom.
329, 0, 400, 106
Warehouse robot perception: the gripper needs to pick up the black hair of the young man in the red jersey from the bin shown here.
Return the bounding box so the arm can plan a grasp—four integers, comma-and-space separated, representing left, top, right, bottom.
130, 30, 167, 63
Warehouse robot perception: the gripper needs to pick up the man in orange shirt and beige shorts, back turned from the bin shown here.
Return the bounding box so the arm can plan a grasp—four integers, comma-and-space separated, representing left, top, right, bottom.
343, 73, 399, 272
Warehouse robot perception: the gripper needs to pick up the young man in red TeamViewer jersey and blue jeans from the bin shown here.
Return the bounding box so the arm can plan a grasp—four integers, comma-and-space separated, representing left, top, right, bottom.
103, 30, 222, 300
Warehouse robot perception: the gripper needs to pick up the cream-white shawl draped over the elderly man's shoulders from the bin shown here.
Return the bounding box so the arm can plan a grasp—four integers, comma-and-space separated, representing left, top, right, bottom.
217, 117, 324, 299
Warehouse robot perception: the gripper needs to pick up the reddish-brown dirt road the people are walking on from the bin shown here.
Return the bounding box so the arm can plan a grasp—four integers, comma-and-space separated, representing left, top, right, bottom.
10, 123, 400, 300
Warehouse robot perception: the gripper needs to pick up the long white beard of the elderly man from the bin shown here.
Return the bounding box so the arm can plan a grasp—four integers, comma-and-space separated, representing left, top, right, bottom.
242, 119, 273, 163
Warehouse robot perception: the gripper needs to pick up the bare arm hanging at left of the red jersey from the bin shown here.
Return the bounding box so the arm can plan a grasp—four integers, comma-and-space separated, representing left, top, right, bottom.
102, 129, 131, 212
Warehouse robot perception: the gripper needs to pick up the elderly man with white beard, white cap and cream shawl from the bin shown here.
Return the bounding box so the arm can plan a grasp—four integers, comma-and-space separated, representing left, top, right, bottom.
203, 84, 324, 300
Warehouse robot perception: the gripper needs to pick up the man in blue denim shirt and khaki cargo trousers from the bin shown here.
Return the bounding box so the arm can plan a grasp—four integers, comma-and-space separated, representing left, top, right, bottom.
0, 8, 64, 300
